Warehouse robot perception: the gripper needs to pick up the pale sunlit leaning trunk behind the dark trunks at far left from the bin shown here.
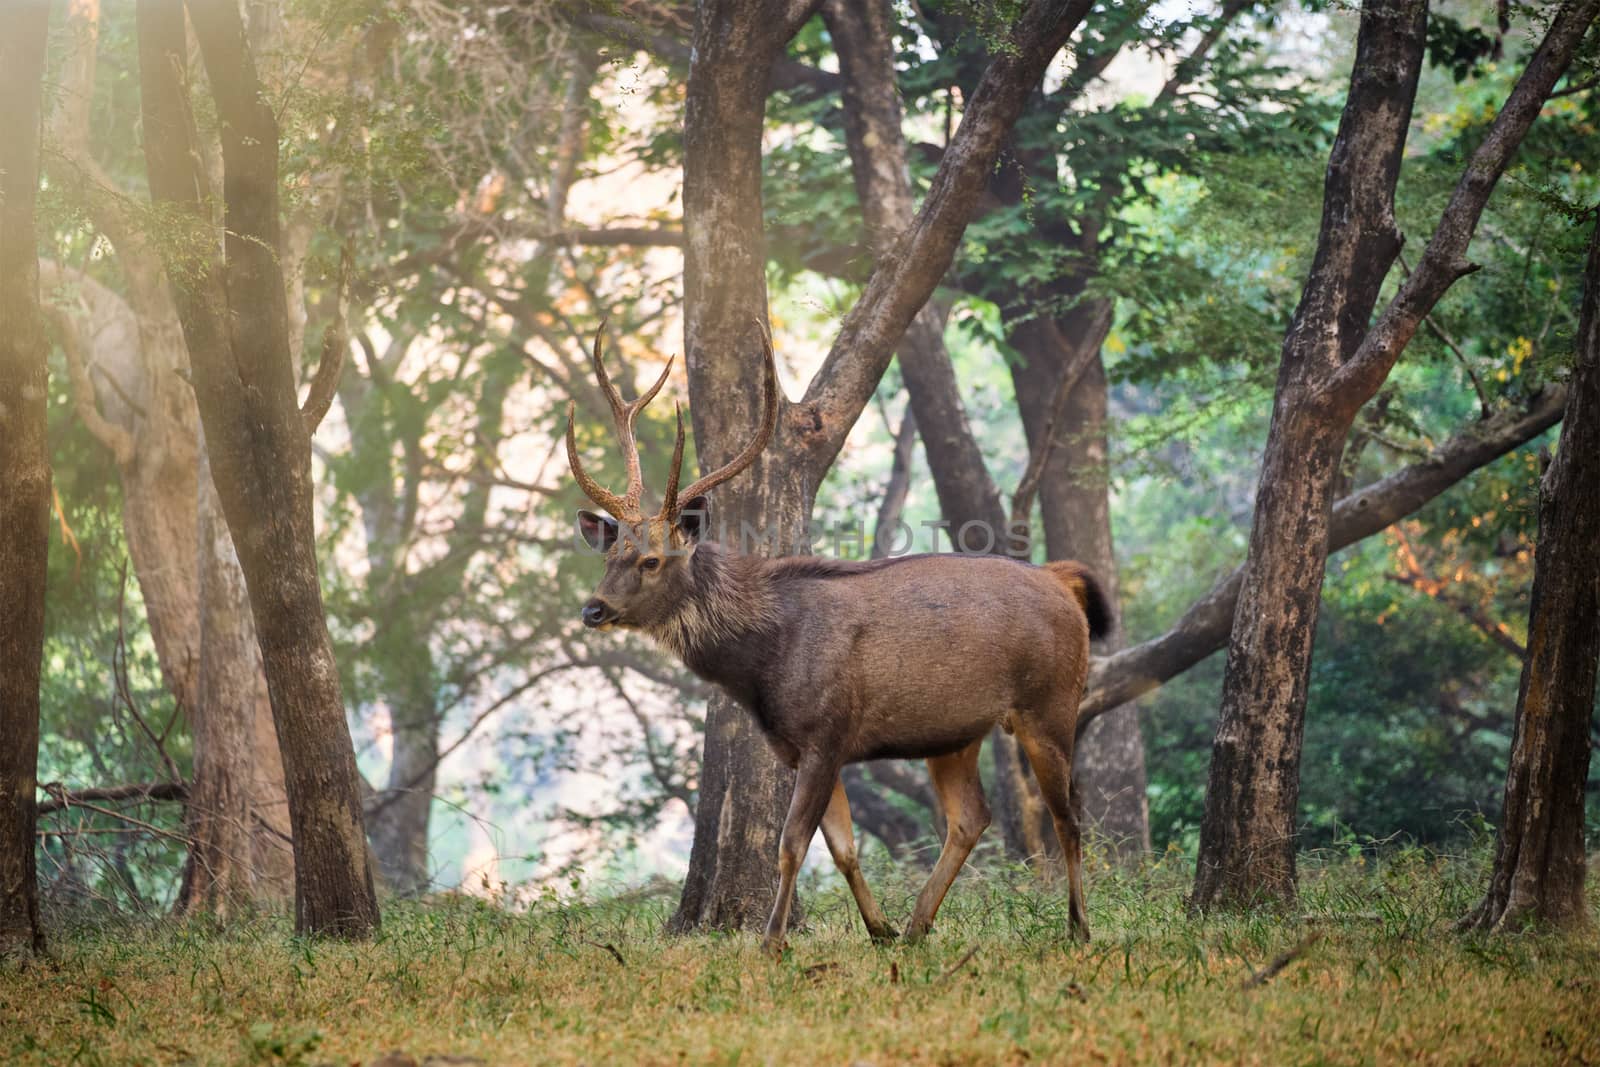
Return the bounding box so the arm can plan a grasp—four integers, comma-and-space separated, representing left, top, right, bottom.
45, 0, 294, 912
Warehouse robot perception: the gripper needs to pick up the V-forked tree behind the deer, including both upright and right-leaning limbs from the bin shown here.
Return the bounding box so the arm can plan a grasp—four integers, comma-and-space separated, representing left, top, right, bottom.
672, 0, 1090, 929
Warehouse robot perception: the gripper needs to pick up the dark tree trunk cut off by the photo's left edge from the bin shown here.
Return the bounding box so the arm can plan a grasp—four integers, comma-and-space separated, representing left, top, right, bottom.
0, 0, 50, 958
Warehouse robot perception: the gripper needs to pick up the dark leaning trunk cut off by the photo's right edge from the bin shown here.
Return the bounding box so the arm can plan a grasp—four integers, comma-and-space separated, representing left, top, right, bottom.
1464, 214, 1600, 929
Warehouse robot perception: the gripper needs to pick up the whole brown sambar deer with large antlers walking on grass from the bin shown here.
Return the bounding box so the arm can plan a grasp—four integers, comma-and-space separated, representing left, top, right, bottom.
566, 323, 1109, 952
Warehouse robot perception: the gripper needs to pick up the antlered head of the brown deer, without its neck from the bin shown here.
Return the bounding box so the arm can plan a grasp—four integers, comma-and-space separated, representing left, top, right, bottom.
566, 326, 778, 630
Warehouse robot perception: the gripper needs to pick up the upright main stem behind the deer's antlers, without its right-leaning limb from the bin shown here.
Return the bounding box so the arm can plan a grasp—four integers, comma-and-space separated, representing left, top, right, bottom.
672, 2, 814, 931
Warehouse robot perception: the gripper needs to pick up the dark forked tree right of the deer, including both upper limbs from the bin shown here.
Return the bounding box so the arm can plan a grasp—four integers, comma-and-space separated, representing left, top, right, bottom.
1192, 0, 1600, 910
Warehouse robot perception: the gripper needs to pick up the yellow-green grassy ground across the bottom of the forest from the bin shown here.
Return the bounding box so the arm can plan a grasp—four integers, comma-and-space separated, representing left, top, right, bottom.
0, 849, 1600, 1067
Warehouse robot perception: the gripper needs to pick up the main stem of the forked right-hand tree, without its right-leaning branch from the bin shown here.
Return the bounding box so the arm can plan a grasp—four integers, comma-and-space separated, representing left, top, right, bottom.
1194, 0, 1427, 909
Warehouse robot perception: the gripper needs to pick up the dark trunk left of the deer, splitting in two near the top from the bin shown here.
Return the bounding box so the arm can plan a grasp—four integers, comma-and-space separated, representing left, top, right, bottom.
138, 0, 378, 937
